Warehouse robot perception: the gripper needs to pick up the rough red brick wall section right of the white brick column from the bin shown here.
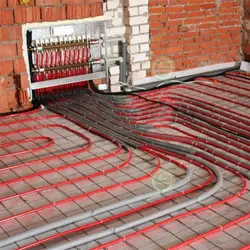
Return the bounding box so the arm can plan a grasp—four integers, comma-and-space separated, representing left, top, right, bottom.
148, 0, 242, 75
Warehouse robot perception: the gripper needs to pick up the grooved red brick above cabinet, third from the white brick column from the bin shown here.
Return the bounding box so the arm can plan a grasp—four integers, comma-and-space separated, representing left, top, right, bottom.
42, 5, 66, 21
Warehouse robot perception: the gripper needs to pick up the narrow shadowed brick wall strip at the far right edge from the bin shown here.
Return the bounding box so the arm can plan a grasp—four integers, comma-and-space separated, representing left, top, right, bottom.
242, 0, 250, 61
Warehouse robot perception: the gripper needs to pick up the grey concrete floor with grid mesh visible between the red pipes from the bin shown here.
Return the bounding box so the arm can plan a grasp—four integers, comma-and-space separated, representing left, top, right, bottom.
0, 74, 250, 250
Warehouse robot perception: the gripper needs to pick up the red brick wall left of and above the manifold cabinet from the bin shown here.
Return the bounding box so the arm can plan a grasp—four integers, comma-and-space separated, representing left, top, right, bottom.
0, 0, 103, 113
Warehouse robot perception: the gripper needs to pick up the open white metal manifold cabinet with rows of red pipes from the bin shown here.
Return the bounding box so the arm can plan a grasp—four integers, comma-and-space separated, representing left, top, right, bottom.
26, 21, 108, 93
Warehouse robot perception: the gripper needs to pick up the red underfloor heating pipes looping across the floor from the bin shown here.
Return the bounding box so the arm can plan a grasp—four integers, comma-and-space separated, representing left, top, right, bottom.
0, 71, 250, 250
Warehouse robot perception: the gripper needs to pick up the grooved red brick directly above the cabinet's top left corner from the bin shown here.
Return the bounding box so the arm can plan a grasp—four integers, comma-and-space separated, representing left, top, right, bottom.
14, 7, 41, 23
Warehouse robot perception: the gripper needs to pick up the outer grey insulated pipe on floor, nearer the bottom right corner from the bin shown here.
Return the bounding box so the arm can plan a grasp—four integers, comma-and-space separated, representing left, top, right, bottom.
48, 163, 223, 250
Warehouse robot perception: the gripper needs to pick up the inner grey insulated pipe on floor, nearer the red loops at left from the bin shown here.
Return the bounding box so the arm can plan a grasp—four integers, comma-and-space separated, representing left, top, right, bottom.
0, 169, 193, 247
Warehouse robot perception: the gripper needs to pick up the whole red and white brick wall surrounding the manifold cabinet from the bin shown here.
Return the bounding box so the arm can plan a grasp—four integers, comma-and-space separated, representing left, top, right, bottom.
0, 0, 245, 113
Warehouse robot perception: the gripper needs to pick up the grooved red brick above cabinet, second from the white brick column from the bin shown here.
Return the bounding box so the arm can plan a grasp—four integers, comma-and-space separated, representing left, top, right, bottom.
67, 4, 90, 19
